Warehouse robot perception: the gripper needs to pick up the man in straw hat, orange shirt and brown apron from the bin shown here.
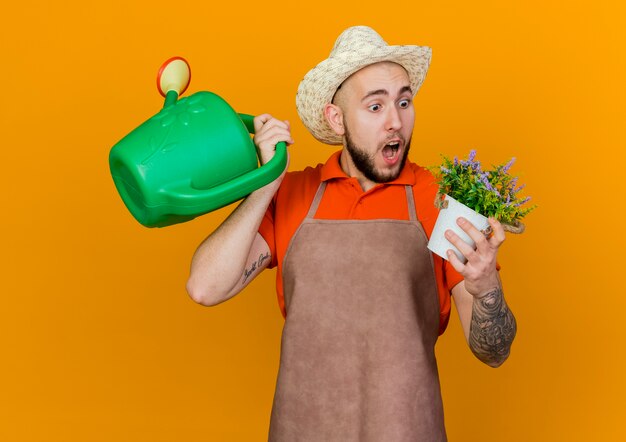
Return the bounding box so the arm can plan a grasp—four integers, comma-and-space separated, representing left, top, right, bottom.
188, 26, 516, 441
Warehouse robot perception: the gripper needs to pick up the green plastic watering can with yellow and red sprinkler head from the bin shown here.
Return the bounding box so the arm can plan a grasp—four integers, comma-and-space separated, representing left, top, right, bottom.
109, 57, 287, 227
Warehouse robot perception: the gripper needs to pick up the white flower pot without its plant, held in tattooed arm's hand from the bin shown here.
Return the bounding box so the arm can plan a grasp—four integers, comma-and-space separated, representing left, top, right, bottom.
428, 195, 490, 263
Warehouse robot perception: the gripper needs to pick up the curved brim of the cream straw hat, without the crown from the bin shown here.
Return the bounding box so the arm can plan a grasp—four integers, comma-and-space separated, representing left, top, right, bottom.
296, 45, 432, 145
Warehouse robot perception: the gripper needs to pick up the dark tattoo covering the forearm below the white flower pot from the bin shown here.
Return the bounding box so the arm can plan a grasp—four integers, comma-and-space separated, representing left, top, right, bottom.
469, 287, 517, 366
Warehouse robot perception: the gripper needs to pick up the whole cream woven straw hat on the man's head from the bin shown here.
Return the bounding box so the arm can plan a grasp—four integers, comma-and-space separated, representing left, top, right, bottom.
296, 26, 432, 145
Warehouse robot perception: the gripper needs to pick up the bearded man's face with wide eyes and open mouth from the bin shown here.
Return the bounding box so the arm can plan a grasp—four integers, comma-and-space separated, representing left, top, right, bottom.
334, 62, 415, 187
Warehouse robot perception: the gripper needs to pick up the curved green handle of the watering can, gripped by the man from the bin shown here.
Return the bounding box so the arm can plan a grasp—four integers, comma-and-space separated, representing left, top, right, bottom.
163, 114, 287, 216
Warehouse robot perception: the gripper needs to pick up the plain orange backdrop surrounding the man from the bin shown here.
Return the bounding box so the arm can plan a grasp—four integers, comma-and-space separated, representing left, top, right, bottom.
0, 0, 626, 441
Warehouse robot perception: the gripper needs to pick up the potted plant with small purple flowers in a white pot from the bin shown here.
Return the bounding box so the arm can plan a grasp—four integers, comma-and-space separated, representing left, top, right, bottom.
428, 150, 536, 263
